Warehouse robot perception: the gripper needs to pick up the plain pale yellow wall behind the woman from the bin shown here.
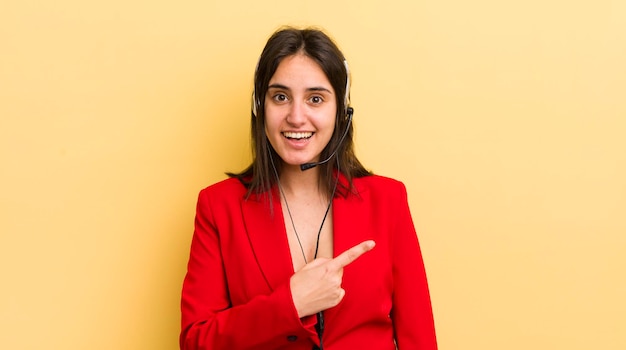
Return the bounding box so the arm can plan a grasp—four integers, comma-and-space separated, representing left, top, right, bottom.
0, 0, 626, 350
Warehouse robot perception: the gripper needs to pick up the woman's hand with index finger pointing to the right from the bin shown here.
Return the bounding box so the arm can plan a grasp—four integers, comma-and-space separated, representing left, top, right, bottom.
290, 240, 376, 317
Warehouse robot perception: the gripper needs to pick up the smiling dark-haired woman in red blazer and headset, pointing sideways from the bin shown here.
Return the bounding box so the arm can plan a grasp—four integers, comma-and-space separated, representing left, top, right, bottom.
180, 28, 437, 350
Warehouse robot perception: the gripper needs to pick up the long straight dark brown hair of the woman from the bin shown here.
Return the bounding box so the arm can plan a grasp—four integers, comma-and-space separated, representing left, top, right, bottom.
227, 27, 371, 198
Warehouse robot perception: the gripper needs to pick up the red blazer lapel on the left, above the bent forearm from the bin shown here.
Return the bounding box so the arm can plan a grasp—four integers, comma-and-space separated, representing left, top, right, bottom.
241, 192, 293, 291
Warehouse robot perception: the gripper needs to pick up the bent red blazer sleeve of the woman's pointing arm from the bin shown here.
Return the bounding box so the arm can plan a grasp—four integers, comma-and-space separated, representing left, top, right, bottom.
180, 191, 315, 350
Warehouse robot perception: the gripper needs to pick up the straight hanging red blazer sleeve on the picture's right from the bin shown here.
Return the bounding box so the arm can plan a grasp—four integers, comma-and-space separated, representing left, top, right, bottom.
391, 184, 437, 350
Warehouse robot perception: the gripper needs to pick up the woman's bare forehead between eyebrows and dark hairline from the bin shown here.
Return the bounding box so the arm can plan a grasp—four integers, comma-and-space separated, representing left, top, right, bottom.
269, 54, 333, 91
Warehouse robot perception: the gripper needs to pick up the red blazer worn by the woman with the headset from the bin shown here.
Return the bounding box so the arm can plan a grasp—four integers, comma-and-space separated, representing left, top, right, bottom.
180, 176, 437, 350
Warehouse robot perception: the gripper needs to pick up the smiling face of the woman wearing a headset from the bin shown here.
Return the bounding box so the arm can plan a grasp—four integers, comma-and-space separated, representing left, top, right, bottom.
265, 54, 337, 170
